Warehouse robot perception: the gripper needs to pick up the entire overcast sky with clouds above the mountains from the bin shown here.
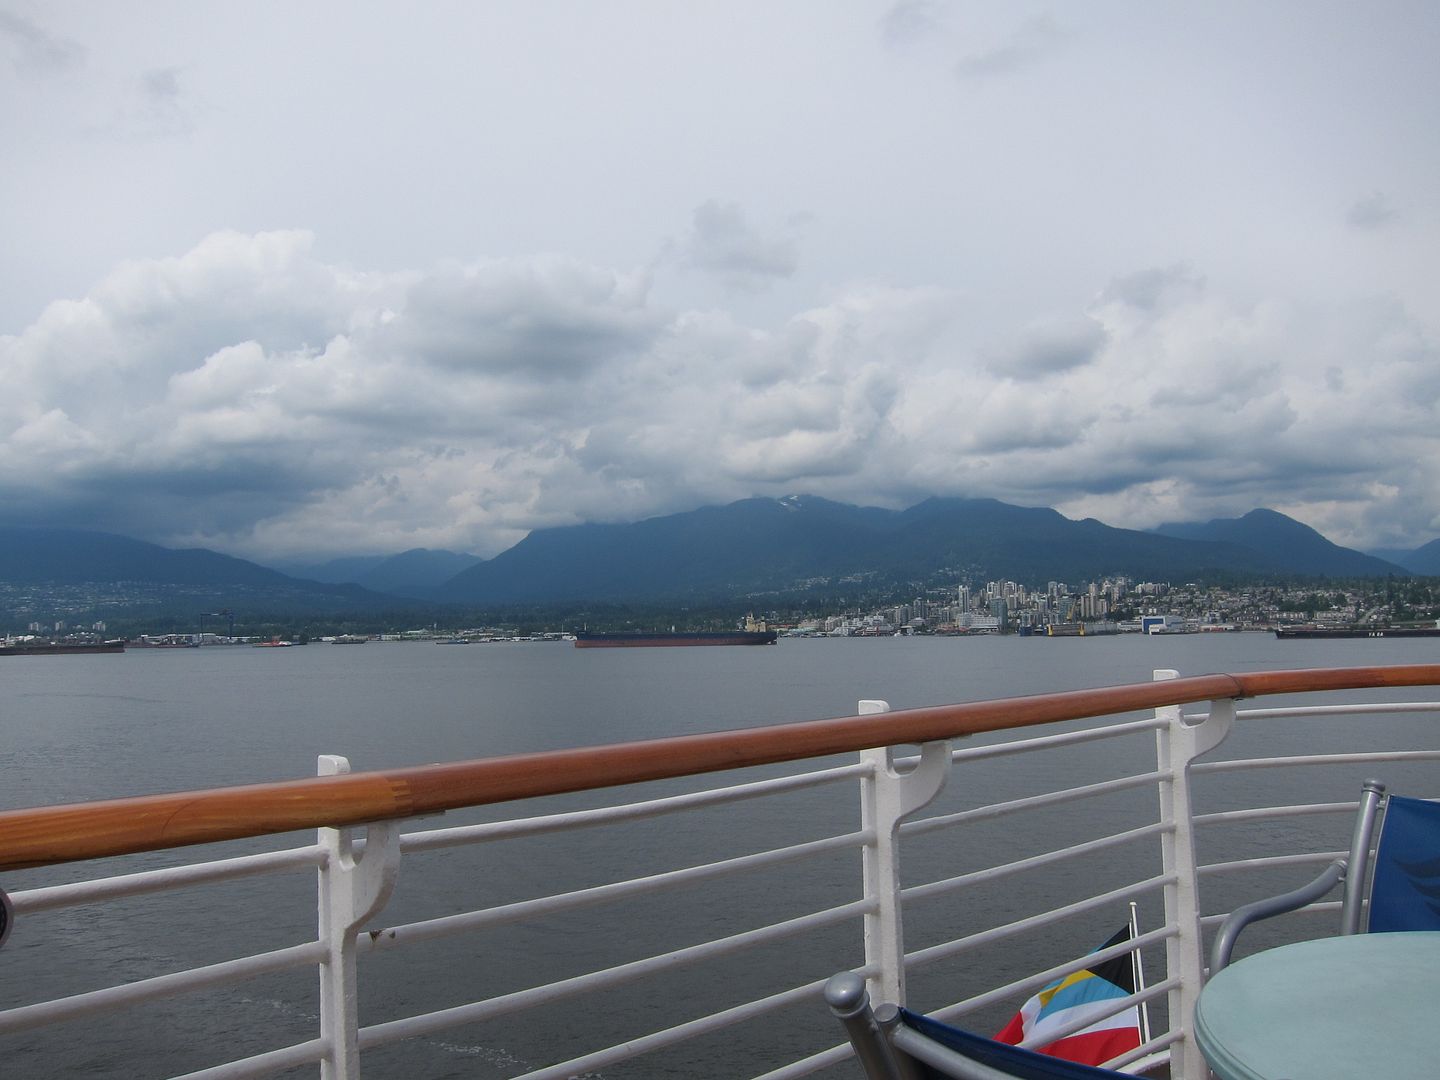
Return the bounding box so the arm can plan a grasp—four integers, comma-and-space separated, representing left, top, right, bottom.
0, 0, 1440, 562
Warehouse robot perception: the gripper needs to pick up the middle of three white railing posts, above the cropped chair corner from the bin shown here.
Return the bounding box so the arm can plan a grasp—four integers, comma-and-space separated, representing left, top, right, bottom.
860, 701, 950, 1005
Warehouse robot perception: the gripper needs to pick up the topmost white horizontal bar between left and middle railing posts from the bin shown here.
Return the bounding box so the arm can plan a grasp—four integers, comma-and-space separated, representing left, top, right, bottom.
400, 763, 874, 851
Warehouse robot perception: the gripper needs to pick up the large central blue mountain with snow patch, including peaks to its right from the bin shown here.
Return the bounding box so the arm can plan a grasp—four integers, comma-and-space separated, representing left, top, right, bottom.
436, 495, 1405, 605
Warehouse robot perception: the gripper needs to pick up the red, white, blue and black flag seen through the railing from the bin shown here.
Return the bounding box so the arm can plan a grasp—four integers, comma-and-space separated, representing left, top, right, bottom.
995, 926, 1140, 1066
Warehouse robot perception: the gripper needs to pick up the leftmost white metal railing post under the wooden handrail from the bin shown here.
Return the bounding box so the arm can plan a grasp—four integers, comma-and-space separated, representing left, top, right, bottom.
317, 755, 400, 1080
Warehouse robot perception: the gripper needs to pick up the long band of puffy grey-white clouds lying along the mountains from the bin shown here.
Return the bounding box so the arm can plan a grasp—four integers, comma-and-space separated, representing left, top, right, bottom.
0, 232, 1440, 557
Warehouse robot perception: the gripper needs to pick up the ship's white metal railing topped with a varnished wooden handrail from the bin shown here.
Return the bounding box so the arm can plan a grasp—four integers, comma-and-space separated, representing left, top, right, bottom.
0, 665, 1440, 1080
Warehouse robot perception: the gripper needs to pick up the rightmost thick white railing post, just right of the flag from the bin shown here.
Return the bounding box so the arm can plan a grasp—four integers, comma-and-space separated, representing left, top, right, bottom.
1155, 668, 1236, 1080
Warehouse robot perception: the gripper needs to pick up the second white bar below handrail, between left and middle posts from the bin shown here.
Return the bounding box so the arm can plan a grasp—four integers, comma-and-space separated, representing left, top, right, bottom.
357, 829, 874, 952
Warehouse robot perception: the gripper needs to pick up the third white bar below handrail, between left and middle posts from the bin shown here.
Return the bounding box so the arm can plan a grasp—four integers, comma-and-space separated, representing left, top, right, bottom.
360, 900, 876, 1050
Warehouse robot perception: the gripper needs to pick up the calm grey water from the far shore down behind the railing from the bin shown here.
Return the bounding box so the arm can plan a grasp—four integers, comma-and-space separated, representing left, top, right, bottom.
0, 634, 1440, 1079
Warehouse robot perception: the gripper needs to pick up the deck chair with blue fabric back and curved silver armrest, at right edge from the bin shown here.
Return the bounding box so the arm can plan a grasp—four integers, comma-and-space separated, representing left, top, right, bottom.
1210, 780, 1440, 975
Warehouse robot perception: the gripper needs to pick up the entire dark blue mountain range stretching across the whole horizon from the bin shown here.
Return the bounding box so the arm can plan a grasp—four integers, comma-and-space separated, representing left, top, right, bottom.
0, 495, 1422, 613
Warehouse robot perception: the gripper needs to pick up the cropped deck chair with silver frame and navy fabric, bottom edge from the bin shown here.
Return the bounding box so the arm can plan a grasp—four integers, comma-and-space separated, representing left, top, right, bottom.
825, 971, 1133, 1080
